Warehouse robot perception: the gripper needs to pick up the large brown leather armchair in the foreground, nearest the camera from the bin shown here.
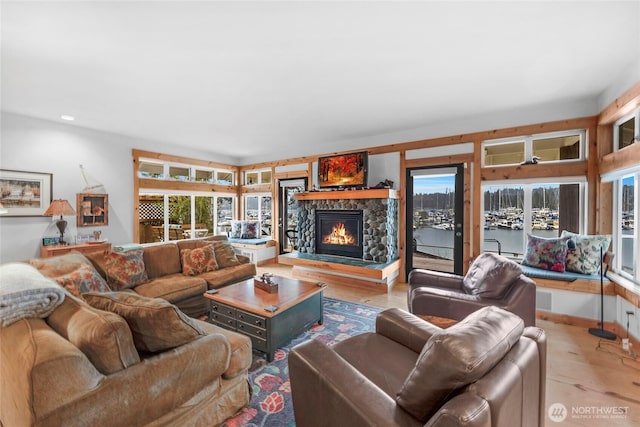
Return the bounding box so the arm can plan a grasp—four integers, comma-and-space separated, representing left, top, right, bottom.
288, 306, 546, 427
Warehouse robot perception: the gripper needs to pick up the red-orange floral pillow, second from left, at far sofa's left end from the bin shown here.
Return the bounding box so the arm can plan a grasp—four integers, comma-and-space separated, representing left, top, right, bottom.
104, 249, 149, 291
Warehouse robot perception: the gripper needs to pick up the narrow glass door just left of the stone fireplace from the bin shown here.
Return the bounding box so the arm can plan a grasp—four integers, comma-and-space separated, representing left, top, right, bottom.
278, 178, 307, 254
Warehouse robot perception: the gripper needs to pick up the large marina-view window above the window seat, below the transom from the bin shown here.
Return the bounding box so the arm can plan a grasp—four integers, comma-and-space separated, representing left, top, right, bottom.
482, 180, 585, 258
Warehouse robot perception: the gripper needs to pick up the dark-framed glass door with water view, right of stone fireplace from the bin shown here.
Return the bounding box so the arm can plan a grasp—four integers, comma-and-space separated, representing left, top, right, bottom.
406, 165, 464, 274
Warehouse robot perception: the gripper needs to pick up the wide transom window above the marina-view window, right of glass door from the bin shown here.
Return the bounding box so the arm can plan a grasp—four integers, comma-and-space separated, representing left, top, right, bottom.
482, 131, 585, 166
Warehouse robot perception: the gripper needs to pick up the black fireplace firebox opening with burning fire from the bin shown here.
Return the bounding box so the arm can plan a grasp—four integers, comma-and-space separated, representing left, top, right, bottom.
316, 210, 363, 258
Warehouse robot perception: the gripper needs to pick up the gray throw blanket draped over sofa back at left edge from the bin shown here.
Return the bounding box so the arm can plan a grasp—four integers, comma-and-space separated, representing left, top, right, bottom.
0, 262, 65, 326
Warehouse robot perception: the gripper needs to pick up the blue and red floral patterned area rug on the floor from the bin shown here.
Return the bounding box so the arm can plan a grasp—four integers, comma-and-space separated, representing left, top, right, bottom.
223, 297, 382, 427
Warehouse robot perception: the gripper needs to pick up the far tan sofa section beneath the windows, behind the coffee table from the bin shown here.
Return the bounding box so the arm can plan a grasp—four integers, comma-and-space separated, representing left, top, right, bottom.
85, 236, 256, 317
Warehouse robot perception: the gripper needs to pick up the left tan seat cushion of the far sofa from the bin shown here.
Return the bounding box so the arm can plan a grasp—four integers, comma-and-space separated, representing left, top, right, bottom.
135, 273, 207, 304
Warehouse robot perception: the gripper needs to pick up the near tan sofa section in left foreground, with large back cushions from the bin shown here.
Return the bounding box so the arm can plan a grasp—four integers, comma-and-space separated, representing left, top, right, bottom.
0, 264, 252, 427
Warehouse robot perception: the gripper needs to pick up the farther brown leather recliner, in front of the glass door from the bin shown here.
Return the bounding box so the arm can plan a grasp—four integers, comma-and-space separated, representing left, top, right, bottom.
407, 252, 536, 326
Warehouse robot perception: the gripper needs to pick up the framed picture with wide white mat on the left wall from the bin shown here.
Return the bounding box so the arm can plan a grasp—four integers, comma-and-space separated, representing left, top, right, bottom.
0, 169, 53, 217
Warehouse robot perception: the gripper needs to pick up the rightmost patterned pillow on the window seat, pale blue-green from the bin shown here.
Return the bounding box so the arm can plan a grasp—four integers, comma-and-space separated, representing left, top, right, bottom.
560, 230, 611, 274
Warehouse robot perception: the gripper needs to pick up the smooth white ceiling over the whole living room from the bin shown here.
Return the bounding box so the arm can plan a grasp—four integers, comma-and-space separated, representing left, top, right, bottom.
1, 0, 640, 163
